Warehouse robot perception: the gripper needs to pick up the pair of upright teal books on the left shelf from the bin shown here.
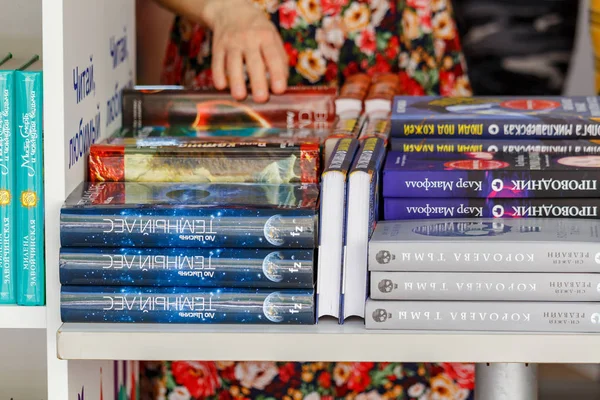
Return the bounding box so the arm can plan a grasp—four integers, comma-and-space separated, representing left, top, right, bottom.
0, 53, 45, 306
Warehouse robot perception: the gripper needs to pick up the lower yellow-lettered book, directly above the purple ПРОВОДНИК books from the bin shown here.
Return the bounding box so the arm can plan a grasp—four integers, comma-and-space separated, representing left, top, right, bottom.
389, 138, 600, 155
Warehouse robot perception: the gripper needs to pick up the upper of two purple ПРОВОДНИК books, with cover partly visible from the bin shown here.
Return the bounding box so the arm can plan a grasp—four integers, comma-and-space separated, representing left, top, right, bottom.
383, 151, 600, 198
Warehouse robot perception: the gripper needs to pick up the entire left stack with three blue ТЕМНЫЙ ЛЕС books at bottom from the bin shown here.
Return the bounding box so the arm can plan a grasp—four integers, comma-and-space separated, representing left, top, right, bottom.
60, 84, 354, 324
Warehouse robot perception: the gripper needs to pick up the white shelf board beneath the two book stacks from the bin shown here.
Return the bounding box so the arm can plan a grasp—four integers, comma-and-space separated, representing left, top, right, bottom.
57, 321, 600, 363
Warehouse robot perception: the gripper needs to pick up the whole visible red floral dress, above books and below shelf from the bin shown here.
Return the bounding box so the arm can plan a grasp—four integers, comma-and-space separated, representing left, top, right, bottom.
157, 0, 474, 400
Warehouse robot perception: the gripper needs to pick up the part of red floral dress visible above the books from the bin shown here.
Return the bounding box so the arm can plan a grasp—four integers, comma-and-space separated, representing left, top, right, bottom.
161, 0, 472, 96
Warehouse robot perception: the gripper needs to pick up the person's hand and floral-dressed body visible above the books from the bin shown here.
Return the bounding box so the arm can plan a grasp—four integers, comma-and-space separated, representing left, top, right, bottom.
138, 0, 471, 101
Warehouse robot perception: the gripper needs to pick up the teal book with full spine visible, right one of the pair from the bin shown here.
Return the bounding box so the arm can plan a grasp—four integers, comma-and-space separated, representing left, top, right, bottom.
15, 70, 45, 306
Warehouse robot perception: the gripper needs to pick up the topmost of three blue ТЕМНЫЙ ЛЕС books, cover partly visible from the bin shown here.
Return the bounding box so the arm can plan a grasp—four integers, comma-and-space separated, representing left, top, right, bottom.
60, 182, 319, 249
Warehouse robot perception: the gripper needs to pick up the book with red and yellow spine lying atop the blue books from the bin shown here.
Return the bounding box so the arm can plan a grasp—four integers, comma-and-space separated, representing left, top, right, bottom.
88, 138, 321, 183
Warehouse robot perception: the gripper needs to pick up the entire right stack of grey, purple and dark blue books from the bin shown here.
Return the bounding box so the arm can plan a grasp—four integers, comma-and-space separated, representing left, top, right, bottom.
366, 97, 600, 332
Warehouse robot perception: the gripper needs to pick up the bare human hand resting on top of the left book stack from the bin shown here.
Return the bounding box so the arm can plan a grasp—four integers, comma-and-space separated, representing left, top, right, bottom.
205, 0, 289, 102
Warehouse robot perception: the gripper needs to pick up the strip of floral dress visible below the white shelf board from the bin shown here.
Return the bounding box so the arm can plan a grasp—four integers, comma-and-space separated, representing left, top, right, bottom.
140, 361, 475, 400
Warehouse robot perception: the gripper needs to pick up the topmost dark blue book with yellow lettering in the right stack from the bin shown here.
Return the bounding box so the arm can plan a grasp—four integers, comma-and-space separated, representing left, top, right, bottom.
391, 96, 600, 139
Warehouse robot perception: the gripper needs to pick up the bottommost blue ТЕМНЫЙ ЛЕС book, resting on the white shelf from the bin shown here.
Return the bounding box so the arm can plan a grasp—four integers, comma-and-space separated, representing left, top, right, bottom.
60, 286, 315, 325
